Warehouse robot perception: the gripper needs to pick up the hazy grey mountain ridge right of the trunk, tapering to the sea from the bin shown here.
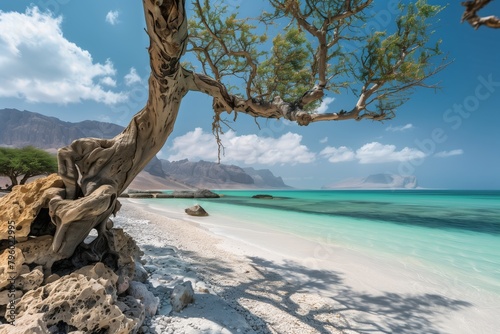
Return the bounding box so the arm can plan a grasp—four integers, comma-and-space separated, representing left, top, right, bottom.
161, 159, 290, 189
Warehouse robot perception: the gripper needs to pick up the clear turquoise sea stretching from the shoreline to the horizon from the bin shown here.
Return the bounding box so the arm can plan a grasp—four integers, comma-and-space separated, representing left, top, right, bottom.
139, 190, 500, 296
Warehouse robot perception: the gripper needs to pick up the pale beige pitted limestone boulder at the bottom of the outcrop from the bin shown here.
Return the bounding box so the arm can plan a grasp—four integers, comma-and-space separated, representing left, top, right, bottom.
12, 264, 141, 334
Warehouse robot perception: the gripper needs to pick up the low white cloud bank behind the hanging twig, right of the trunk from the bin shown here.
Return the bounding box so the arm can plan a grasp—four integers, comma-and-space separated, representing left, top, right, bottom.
168, 128, 315, 165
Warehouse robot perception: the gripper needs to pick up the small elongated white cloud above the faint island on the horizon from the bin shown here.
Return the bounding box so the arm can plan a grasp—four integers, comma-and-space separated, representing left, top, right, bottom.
320, 142, 425, 164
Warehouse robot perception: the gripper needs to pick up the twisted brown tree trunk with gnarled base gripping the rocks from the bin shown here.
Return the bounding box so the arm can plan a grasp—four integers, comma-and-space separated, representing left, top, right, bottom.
49, 0, 188, 257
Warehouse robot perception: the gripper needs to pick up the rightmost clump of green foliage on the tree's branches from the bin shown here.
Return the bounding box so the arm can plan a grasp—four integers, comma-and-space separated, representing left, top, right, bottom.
356, 0, 441, 112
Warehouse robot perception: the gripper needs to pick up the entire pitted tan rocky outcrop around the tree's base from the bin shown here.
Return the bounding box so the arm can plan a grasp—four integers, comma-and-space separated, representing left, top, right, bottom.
0, 174, 152, 334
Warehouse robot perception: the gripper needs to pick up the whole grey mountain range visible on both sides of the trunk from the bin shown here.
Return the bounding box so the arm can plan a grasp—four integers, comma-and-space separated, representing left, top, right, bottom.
0, 109, 290, 190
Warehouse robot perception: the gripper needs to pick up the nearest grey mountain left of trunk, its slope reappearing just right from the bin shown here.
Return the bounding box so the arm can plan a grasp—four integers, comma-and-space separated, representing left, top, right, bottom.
0, 109, 165, 177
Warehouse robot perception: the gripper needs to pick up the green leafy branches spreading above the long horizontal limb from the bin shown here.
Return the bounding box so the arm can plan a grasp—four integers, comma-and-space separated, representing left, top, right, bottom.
189, 0, 446, 119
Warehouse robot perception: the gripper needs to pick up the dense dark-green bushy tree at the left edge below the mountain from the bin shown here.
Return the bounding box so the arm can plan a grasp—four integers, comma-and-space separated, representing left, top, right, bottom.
0, 146, 57, 185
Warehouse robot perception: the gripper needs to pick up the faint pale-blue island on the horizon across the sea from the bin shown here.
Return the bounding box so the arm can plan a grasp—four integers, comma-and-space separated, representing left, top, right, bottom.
323, 174, 418, 189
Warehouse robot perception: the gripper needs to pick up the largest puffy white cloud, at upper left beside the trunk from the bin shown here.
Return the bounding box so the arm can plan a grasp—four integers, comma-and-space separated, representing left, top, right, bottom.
0, 7, 126, 104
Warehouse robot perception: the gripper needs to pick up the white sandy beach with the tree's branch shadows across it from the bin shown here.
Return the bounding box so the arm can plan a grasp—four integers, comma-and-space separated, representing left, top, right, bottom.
115, 199, 500, 334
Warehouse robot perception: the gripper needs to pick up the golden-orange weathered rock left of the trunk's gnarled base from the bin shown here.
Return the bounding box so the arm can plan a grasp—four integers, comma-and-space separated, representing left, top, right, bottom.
0, 174, 64, 241
